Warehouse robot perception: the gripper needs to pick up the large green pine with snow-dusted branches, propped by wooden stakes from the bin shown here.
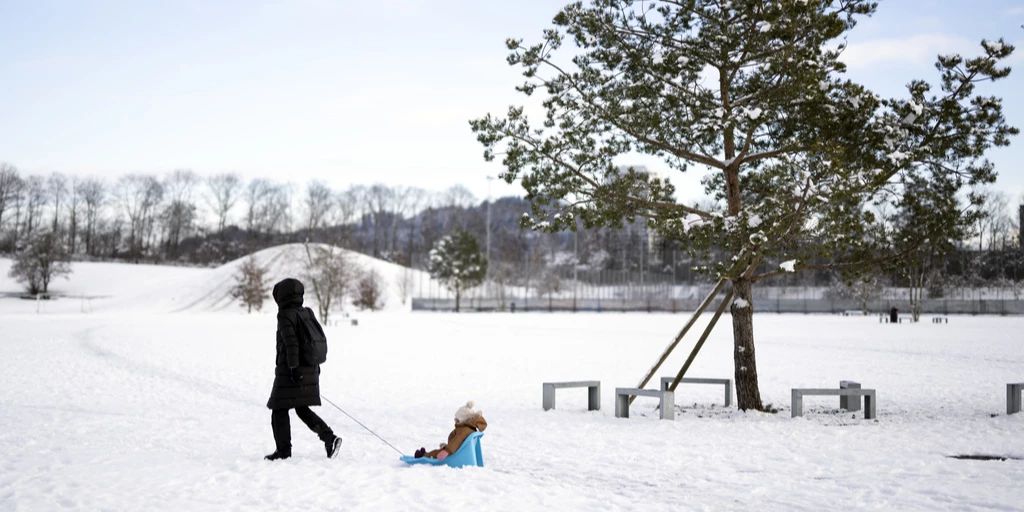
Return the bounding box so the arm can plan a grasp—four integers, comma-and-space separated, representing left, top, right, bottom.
471, 0, 1016, 410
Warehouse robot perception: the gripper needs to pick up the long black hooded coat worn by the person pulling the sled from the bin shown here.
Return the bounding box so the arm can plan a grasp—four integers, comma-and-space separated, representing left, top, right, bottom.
266, 278, 321, 409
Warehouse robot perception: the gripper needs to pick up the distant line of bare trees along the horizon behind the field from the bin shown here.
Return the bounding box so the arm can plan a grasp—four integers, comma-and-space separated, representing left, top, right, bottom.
0, 163, 1024, 294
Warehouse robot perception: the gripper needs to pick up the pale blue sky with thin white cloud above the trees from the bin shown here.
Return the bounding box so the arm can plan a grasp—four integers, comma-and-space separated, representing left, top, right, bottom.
0, 0, 1024, 203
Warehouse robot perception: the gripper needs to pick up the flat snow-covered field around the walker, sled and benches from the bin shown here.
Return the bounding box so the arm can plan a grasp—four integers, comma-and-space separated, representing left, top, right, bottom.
0, 256, 1024, 511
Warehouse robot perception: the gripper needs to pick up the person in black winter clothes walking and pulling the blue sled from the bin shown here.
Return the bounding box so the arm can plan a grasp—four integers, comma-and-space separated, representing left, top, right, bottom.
265, 278, 341, 461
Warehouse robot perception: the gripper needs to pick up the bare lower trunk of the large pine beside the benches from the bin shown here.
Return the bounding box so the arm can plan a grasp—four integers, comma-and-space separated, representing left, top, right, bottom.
730, 278, 764, 411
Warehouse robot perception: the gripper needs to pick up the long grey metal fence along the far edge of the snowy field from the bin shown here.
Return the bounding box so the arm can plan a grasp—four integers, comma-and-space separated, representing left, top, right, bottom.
411, 262, 1024, 314
